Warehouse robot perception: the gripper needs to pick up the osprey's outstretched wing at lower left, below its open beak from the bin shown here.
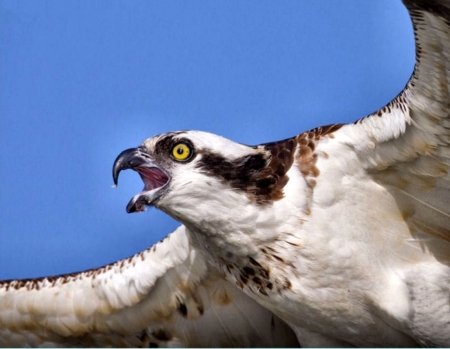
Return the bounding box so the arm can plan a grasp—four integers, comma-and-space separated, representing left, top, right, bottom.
0, 226, 298, 347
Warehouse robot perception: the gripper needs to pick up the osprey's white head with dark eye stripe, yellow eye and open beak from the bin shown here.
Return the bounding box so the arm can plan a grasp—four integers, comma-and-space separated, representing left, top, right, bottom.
113, 131, 295, 226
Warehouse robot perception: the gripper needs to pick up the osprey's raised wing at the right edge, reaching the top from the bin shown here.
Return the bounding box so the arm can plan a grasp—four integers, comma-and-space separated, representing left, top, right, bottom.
324, 0, 450, 263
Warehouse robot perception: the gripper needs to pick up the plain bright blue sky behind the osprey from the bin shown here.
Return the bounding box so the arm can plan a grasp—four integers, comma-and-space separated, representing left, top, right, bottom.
0, 0, 414, 279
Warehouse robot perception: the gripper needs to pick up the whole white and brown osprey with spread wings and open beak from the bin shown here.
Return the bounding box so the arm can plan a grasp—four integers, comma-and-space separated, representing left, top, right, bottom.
0, 0, 450, 347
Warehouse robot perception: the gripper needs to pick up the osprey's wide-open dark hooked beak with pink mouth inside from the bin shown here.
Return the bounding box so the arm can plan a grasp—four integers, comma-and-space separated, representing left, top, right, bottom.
112, 147, 170, 213
